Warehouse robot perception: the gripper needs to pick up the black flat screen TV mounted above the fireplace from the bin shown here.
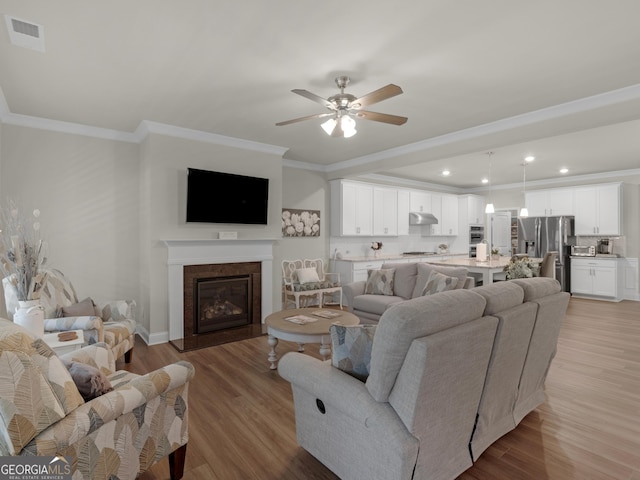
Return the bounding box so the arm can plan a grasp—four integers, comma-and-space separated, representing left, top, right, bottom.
187, 168, 269, 225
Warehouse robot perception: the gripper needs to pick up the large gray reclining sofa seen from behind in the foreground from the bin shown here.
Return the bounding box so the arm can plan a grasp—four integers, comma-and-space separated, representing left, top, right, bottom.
278, 278, 569, 480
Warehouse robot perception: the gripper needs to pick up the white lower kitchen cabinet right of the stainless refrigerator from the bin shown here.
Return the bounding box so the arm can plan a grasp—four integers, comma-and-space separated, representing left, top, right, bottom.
571, 257, 620, 300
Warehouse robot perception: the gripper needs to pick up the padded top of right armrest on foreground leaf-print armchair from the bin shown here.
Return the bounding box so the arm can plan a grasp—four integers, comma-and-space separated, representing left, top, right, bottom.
25, 361, 194, 455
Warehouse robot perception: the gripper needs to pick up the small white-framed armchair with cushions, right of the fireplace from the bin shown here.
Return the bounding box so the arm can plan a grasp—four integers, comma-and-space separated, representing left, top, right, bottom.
282, 258, 342, 308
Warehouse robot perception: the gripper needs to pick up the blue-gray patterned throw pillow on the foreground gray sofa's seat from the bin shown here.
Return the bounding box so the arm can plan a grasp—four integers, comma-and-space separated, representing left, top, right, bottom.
329, 325, 376, 381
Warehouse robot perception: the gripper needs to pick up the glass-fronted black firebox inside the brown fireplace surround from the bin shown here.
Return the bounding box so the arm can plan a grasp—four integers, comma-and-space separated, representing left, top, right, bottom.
193, 275, 253, 334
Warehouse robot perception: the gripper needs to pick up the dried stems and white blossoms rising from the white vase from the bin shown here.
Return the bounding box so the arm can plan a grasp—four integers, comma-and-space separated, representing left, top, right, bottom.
0, 202, 47, 301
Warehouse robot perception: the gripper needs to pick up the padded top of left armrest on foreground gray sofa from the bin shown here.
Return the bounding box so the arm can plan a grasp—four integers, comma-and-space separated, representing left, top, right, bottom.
278, 352, 398, 426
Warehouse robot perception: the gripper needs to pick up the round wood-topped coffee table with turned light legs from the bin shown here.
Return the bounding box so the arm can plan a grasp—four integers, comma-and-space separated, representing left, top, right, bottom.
265, 308, 360, 370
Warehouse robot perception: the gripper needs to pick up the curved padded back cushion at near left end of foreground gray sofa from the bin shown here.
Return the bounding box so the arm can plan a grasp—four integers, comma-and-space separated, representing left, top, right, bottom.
366, 289, 486, 402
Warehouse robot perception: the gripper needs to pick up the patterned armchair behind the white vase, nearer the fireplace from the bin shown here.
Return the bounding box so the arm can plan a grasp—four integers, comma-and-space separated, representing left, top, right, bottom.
2, 269, 136, 363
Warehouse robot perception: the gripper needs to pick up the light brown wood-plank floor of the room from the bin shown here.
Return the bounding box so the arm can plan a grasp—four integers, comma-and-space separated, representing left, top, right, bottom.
118, 298, 640, 480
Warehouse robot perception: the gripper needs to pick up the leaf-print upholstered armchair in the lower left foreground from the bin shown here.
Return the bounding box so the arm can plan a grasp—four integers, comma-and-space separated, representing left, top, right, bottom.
0, 319, 194, 480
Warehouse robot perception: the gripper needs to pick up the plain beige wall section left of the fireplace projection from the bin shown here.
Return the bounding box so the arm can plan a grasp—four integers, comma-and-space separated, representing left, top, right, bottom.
0, 125, 139, 310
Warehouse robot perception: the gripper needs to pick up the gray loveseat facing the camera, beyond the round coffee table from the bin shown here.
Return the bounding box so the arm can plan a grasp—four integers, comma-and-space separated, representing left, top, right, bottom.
342, 263, 475, 323
